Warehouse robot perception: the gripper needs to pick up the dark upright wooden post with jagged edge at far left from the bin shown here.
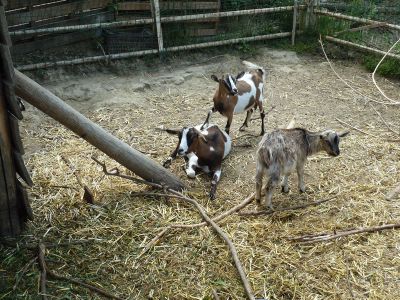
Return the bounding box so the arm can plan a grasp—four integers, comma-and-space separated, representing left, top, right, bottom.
0, 0, 33, 238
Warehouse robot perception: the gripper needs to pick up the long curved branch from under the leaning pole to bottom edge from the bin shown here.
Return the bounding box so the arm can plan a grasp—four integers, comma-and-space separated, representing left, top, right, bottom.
92, 157, 255, 300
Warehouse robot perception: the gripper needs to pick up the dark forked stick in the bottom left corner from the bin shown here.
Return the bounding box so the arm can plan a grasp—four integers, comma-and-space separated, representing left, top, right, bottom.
37, 243, 122, 300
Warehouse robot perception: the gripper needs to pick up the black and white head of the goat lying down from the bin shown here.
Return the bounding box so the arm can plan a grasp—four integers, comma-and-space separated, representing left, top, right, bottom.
167, 127, 207, 156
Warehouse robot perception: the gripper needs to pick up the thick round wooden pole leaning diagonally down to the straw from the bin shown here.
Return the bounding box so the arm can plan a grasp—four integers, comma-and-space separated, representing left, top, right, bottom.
15, 70, 184, 190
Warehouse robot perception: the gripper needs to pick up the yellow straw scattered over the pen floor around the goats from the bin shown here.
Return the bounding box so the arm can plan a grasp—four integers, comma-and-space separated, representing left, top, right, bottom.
6, 54, 400, 299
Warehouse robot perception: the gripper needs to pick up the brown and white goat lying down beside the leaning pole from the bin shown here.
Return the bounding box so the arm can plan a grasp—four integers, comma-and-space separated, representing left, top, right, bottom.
164, 124, 232, 200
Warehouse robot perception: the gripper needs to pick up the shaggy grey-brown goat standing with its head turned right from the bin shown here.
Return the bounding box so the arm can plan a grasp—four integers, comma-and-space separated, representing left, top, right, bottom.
256, 128, 349, 209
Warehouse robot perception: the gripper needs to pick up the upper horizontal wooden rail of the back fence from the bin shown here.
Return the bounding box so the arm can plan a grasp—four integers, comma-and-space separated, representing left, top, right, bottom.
10, 5, 305, 36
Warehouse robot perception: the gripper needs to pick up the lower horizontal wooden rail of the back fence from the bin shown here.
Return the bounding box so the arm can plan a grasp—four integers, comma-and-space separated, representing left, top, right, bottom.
17, 31, 294, 71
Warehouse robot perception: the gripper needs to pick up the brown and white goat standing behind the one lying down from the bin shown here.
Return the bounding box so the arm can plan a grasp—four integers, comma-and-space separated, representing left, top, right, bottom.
204, 61, 265, 135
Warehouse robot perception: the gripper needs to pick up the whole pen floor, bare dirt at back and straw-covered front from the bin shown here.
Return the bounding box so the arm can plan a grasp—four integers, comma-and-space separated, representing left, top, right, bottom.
5, 48, 400, 299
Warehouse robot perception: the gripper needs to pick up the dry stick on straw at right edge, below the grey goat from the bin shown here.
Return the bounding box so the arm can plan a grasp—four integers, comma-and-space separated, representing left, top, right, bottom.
289, 224, 400, 244
